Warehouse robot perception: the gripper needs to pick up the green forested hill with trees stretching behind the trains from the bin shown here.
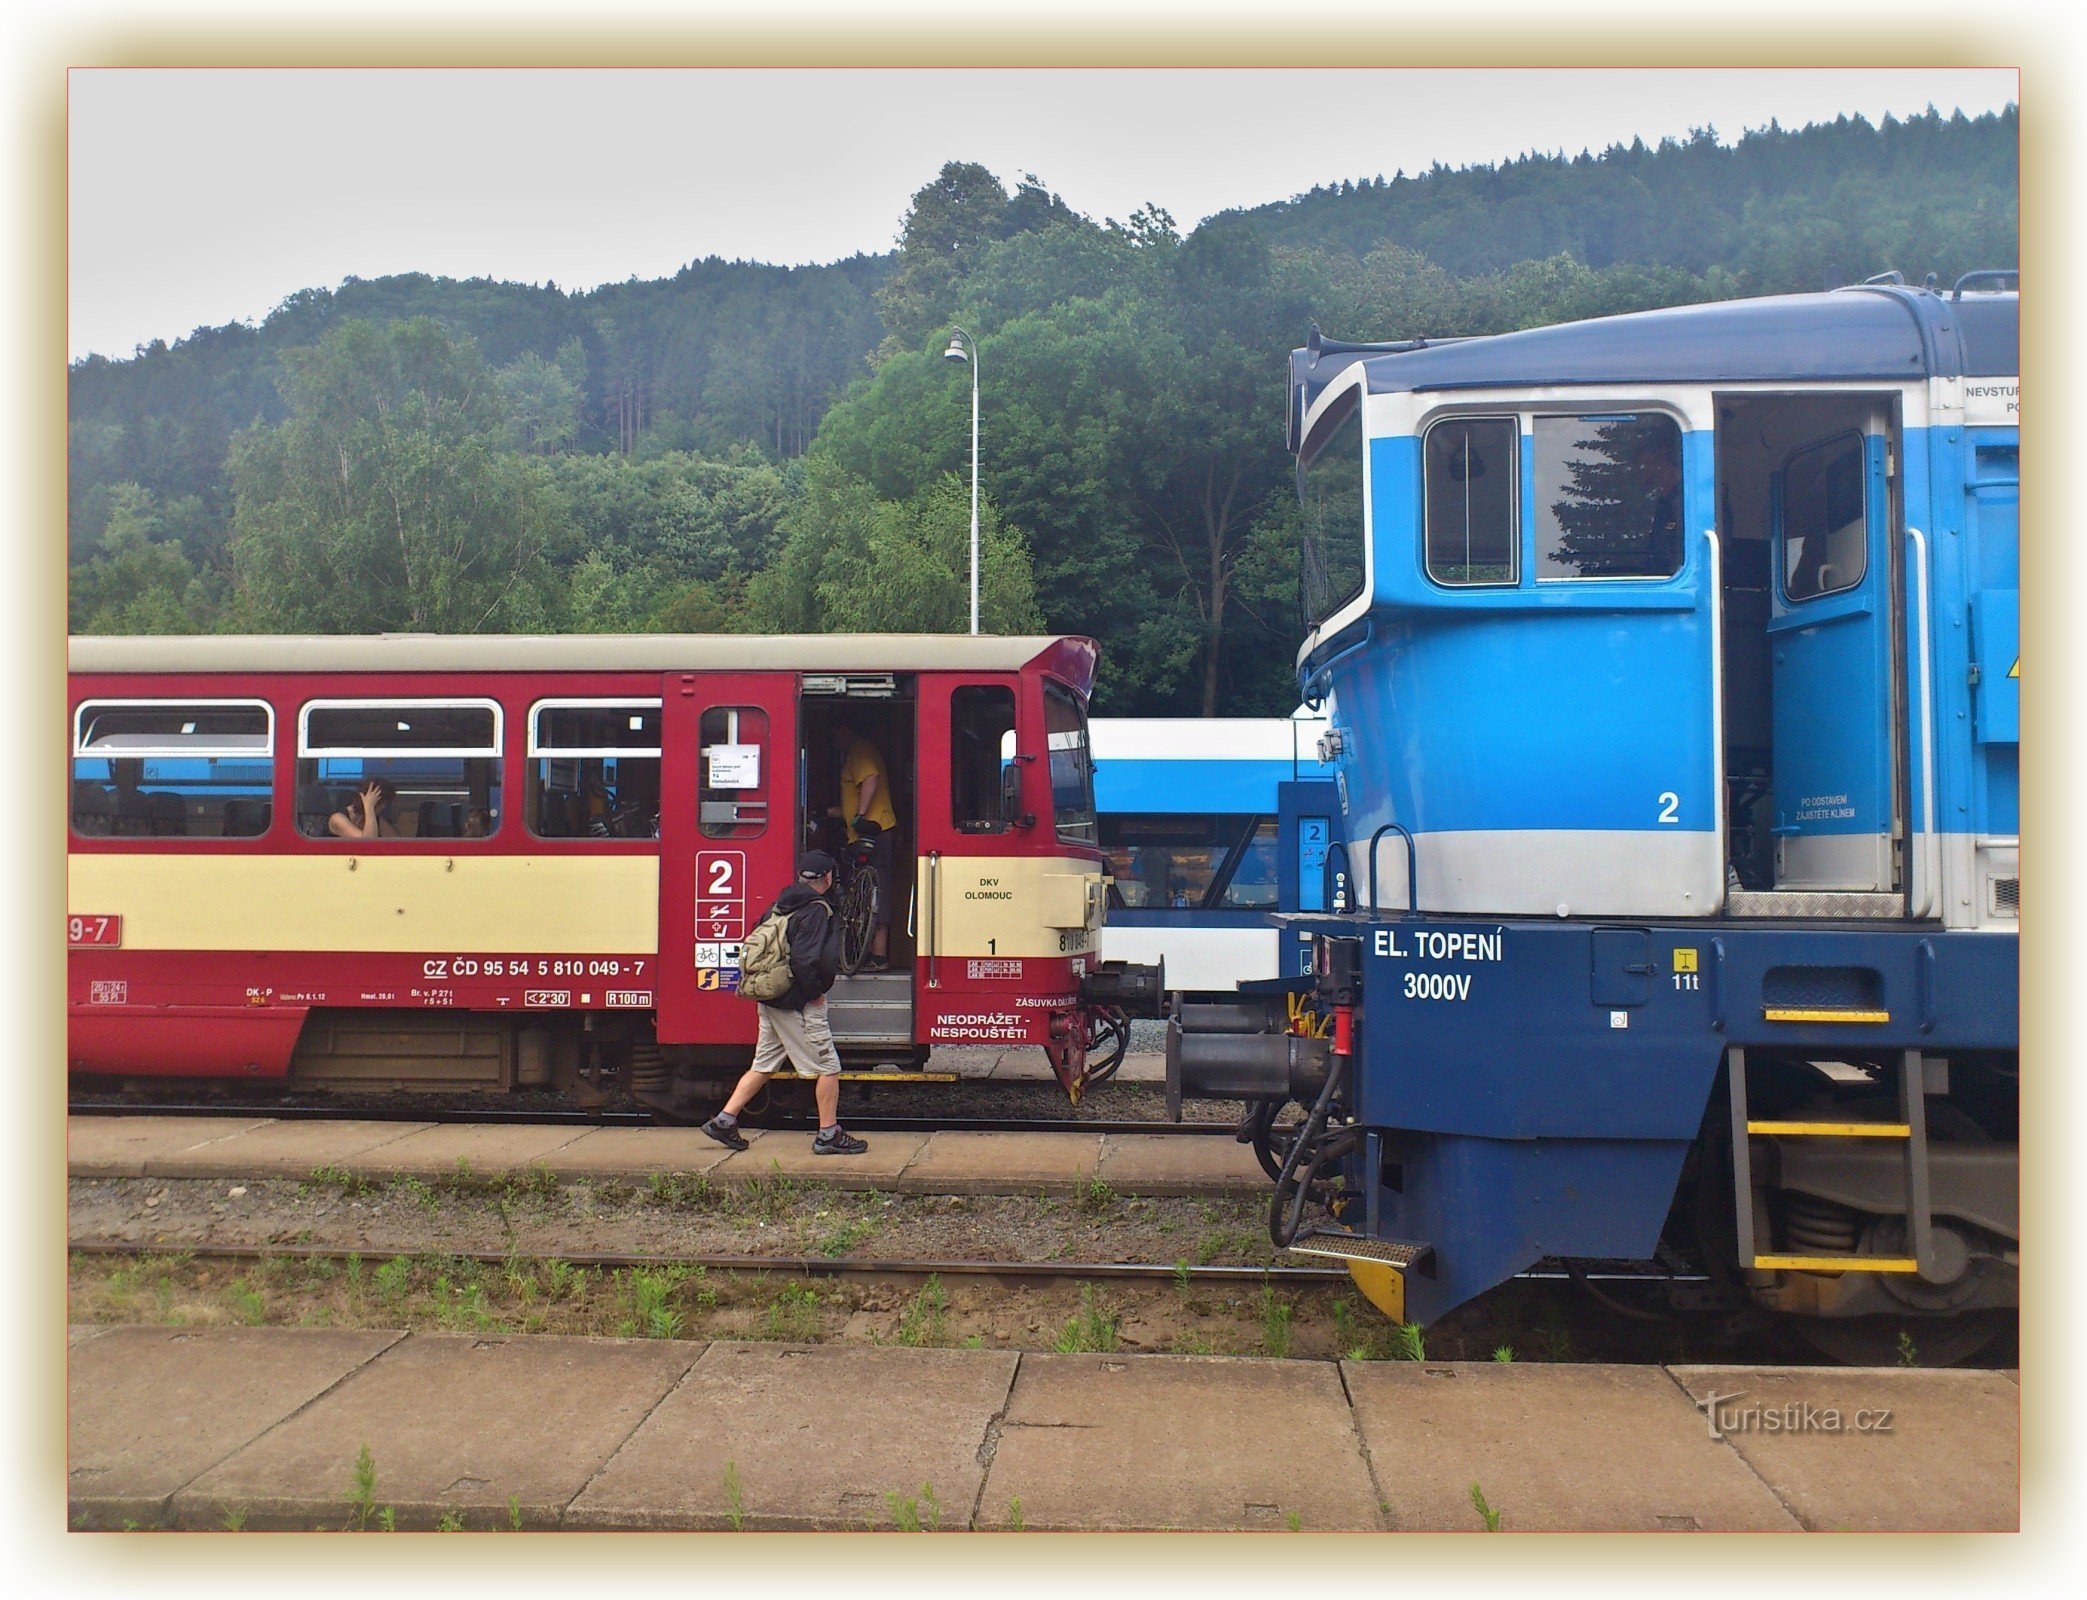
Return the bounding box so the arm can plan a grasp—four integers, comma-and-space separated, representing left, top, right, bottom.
69, 108, 2018, 713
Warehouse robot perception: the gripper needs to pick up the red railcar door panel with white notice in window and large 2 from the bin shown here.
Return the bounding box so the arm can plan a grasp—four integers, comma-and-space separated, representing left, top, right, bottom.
655, 672, 799, 1045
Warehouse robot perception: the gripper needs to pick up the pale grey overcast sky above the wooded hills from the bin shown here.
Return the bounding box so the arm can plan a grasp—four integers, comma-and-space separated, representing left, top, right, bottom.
69, 67, 2016, 359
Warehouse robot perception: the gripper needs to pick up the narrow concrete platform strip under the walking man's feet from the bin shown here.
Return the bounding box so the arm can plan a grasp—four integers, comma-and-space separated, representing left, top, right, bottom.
67, 1116, 1269, 1195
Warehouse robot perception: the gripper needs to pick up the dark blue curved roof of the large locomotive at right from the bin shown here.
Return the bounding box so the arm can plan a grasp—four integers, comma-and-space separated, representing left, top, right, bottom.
1290, 284, 2020, 449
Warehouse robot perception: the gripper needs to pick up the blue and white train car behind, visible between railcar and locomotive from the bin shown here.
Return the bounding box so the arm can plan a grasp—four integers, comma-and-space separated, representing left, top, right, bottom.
1089, 707, 1342, 993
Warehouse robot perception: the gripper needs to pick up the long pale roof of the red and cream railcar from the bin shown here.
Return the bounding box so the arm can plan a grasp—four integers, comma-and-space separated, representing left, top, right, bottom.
67, 634, 1096, 688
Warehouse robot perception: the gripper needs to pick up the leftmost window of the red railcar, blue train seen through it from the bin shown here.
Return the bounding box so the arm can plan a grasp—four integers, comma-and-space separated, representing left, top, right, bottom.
73, 701, 275, 839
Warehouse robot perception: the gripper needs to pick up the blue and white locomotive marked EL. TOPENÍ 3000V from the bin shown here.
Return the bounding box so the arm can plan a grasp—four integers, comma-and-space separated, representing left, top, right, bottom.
1169, 271, 2020, 1360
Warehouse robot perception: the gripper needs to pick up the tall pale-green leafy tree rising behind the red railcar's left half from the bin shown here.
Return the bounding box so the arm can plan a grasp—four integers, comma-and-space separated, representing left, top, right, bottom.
230, 317, 559, 632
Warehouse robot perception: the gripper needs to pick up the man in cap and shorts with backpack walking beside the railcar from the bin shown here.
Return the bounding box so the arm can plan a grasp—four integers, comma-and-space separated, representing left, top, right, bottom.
703, 849, 870, 1156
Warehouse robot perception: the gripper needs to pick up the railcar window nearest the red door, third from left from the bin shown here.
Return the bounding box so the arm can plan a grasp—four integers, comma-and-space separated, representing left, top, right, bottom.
528, 701, 659, 839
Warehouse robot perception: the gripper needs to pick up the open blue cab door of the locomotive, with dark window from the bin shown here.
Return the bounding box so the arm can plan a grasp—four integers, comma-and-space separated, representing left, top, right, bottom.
1768, 409, 1899, 893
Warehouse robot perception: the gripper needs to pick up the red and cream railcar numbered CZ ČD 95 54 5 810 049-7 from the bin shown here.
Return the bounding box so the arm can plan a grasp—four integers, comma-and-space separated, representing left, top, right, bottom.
67, 634, 1135, 1095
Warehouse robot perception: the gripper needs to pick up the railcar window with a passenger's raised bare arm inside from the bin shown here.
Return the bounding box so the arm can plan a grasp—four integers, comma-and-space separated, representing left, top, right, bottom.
296, 699, 501, 843
